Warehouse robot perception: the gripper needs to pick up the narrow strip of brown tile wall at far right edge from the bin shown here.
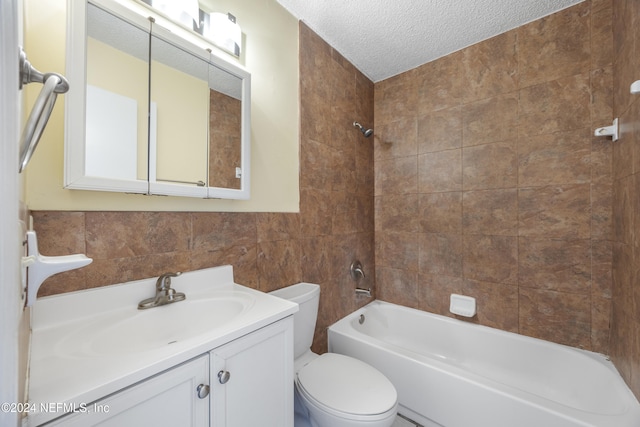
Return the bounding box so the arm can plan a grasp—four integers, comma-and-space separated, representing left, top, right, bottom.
611, 0, 640, 398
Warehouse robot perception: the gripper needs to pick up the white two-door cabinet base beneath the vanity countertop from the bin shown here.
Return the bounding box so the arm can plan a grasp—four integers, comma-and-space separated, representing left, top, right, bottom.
39, 316, 293, 427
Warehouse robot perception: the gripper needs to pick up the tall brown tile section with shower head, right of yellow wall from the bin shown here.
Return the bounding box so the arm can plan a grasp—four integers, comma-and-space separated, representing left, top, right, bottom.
300, 22, 375, 349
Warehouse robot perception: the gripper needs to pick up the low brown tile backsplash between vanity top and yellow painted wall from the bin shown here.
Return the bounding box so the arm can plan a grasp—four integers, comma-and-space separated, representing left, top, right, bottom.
32, 211, 302, 296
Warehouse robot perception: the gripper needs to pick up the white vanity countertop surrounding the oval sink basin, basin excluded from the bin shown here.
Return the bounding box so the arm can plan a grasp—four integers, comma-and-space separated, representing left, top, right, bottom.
23, 266, 298, 427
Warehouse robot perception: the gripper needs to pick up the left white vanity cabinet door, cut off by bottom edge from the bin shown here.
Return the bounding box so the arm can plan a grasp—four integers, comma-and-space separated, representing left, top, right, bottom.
51, 355, 209, 427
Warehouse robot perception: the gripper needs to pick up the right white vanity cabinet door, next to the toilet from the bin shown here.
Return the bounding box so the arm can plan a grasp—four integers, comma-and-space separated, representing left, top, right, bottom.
211, 317, 293, 427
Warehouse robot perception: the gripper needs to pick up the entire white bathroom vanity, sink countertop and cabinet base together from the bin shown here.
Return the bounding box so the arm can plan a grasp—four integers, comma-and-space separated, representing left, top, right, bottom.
22, 265, 298, 427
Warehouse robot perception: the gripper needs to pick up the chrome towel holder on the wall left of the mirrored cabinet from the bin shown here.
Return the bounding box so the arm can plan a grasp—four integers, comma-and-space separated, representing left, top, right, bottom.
19, 47, 69, 172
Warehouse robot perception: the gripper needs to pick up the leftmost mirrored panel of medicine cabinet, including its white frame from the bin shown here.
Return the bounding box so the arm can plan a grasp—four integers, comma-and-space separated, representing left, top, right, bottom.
65, 2, 150, 194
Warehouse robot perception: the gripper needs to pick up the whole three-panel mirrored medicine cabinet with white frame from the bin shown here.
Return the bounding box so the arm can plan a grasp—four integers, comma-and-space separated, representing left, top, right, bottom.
65, 0, 250, 199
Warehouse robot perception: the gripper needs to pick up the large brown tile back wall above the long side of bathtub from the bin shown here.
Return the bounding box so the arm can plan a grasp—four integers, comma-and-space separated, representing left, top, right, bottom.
374, 0, 616, 353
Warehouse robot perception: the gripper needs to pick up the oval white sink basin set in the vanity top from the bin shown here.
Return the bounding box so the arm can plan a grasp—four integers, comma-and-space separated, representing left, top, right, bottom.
56, 292, 254, 357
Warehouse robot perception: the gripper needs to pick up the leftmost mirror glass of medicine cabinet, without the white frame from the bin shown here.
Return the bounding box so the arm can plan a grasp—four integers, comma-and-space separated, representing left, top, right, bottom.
85, 5, 149, 181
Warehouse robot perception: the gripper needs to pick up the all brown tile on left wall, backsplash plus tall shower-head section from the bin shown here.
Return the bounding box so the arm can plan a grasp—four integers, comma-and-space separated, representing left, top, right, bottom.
32, 20, 375, 352
